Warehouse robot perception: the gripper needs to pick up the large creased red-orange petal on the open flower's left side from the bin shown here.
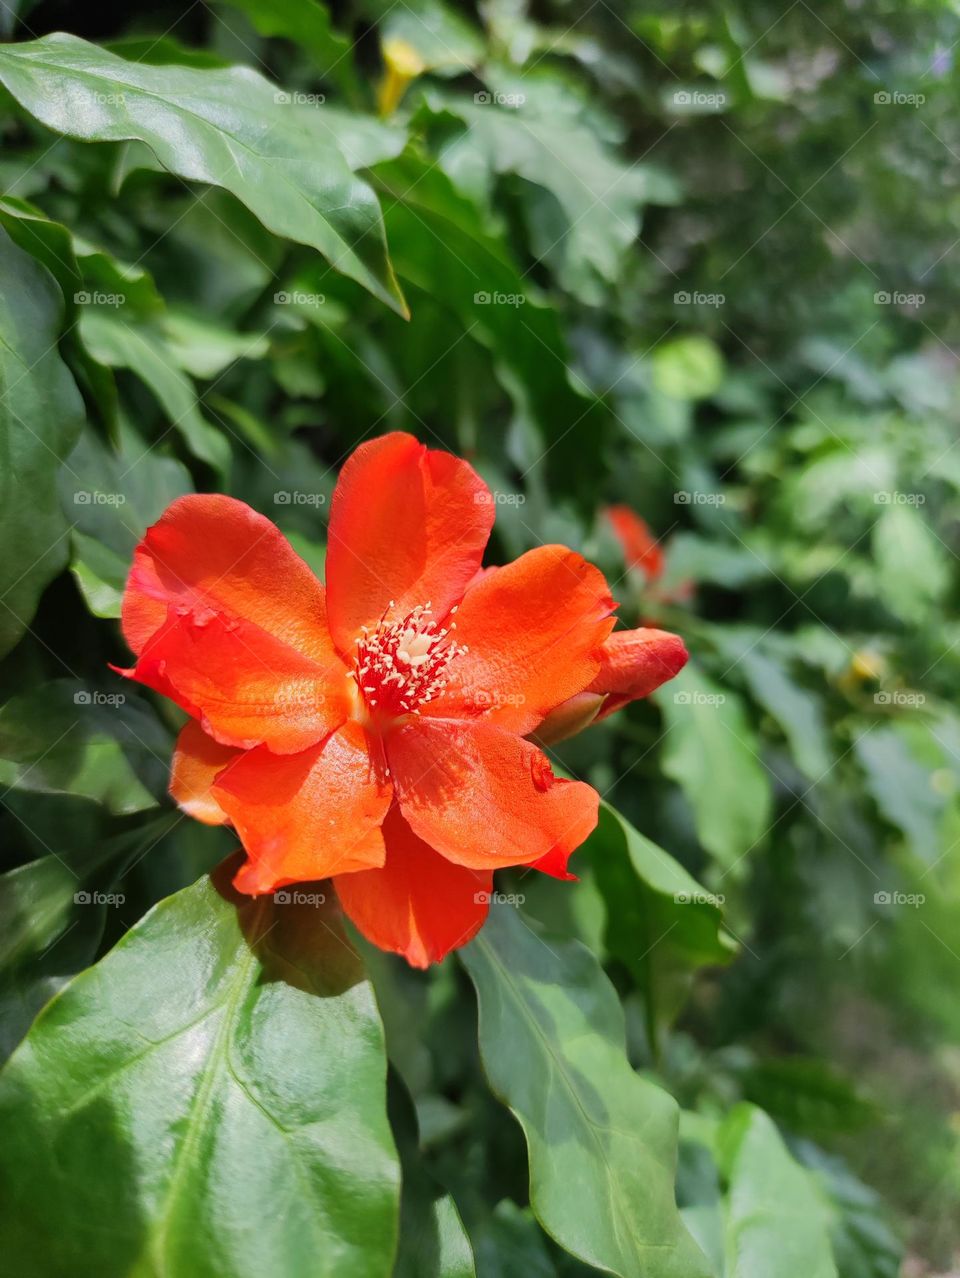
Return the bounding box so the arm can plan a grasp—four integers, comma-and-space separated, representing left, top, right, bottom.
123, 495, 349, 751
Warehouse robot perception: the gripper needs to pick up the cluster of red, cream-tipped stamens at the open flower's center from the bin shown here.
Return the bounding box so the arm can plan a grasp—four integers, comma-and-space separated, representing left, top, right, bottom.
349, 599, 467, 717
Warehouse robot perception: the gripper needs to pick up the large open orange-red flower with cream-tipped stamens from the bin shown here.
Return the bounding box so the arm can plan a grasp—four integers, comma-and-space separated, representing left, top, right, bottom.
123, 433, 683, 966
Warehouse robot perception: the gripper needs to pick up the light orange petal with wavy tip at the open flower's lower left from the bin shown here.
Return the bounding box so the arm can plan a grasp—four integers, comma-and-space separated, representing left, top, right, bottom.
213, 722, 390, 896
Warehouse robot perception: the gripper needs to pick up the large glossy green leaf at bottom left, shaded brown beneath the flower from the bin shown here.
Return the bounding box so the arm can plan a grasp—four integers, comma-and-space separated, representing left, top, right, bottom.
0, 863, 399, 1278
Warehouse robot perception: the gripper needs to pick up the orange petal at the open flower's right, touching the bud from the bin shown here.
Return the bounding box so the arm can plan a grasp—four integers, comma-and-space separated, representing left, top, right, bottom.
424, 546, 614, 734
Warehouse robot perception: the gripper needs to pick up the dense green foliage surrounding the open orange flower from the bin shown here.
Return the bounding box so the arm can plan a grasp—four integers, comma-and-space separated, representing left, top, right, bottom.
0, 0, 960, 1278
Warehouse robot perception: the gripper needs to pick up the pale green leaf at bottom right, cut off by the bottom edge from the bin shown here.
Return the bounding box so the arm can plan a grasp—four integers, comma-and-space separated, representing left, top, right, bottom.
718, 1104, 837, 1278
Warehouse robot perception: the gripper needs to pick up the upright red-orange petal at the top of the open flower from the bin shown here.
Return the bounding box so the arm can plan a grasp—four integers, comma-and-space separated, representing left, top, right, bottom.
326, 432, 495, 657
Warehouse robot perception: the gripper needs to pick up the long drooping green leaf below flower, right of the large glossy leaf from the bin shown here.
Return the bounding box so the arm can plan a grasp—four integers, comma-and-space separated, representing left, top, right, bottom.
460, 906, 706, 1278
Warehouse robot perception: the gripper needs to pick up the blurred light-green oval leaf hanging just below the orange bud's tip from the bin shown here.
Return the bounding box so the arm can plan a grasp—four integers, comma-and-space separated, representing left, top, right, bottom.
654, 662, 771, 870
